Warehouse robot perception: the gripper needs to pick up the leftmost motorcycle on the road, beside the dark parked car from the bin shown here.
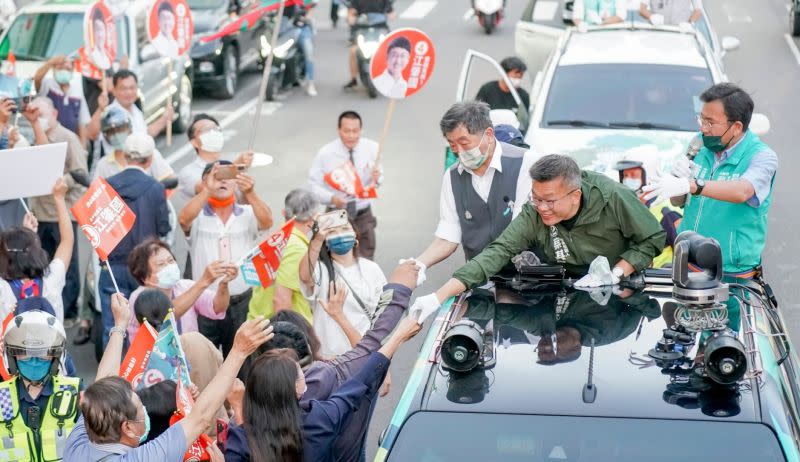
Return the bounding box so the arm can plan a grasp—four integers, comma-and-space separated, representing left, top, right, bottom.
258, 17, 306, 101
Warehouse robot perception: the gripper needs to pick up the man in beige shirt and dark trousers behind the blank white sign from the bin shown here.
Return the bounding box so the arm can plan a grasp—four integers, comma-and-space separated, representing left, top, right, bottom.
30, 96, 89, 318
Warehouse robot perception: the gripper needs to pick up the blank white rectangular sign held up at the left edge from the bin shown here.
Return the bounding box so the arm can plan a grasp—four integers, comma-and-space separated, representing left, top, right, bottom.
0, 143, 67, 200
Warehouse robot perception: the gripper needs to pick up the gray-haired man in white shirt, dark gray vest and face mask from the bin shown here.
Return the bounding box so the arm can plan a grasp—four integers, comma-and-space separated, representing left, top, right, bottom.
416, 101, 535, 272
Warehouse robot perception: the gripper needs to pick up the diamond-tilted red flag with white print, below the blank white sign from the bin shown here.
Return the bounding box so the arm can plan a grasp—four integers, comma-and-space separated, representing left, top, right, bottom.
71, 178, 136, 261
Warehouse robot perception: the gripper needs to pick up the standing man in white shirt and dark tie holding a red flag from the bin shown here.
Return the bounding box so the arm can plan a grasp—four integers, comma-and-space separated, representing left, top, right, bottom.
308, 111, 383, 260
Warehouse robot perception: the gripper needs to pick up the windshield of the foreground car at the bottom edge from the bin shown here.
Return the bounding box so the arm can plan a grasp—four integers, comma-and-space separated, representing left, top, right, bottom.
389, 412, 784, 462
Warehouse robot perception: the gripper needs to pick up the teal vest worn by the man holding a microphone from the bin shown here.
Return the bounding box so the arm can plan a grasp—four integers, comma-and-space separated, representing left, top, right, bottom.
678, 130, 775, 273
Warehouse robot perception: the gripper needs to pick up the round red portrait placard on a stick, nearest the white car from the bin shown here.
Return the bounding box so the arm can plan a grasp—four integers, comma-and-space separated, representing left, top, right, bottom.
370, 28, 436, 99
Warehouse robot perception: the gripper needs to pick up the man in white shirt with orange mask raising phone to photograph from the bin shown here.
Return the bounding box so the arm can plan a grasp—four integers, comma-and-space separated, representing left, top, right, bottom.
178, 160, 272, 355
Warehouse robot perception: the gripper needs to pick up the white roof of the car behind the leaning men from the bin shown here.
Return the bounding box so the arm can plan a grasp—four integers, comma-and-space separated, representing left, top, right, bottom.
558, 29, 708, 68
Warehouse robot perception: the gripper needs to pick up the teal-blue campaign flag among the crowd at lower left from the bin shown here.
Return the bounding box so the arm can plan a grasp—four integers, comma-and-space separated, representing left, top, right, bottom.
137, 311, 191, 390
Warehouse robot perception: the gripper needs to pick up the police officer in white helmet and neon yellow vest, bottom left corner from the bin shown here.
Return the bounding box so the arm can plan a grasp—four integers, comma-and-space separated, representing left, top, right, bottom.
0, 310, 80, 462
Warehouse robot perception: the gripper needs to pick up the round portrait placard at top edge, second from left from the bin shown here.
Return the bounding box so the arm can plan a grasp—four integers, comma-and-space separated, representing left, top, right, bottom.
147, 0, 194, 59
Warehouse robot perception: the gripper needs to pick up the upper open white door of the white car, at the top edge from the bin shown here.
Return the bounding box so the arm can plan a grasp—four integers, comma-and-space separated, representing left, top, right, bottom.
514, 0, 567, 73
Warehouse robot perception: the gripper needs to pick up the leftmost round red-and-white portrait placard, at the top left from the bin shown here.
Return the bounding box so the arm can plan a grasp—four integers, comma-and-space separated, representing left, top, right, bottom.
83, 0, 117, 70
